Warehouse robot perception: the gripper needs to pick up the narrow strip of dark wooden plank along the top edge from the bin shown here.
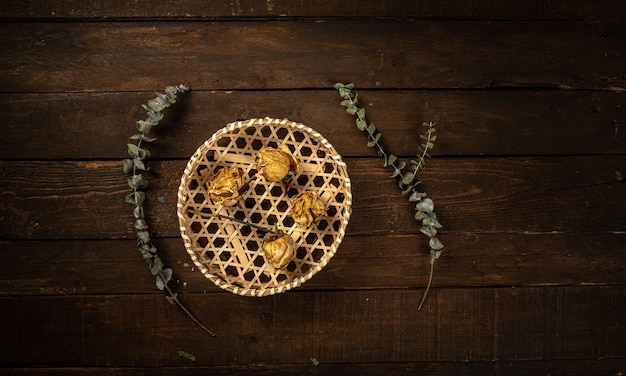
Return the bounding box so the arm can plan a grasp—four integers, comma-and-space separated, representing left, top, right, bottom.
0, 0, 626, 20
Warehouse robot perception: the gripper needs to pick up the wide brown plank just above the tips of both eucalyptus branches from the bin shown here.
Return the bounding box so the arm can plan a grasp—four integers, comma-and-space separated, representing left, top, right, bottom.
0, 21, 626, 93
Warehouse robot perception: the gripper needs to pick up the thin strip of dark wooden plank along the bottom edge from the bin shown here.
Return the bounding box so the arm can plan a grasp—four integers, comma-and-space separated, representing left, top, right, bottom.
2, 358, 625, 376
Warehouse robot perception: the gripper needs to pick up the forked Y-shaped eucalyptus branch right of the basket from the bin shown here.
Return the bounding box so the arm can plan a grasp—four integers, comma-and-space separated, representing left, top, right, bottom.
333, 83, 444, 310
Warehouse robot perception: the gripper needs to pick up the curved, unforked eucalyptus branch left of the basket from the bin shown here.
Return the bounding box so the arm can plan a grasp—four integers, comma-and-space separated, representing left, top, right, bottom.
124, 84, 215, 336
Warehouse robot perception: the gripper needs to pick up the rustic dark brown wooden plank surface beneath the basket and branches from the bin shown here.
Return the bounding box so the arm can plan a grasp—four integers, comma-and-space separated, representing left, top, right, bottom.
0, 0, 626, 375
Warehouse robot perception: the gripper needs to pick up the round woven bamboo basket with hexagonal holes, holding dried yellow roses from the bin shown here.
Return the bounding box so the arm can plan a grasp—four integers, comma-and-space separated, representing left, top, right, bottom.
177, 118, 352, 296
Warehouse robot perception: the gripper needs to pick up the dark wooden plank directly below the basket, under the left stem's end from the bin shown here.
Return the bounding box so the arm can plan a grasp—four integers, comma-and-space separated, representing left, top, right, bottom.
0, 286, 626, 367
